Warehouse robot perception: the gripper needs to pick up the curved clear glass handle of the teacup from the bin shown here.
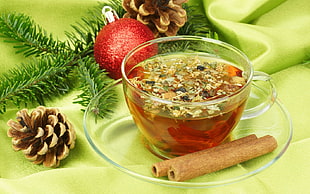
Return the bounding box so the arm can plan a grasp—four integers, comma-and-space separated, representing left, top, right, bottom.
241, 71, 277, 120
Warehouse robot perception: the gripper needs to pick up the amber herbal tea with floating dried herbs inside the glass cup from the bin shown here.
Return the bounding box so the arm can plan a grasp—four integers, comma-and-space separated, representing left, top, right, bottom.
125, 53, 248, 157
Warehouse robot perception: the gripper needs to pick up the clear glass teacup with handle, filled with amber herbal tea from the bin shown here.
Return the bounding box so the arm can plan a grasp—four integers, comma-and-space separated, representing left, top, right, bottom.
121, 36, 276, 158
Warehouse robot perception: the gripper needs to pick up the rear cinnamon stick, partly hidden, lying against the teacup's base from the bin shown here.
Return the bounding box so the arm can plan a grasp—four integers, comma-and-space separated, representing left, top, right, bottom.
152, 134, 257, 177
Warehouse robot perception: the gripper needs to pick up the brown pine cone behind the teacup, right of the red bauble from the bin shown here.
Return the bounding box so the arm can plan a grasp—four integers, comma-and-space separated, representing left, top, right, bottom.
123, 0, 187, 37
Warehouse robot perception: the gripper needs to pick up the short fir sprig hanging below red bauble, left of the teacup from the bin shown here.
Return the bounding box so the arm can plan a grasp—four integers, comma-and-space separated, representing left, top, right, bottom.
74, 57, 118, 118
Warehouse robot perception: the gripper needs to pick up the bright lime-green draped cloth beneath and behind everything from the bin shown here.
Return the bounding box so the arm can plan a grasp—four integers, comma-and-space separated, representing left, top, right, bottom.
0, 0, 310, 194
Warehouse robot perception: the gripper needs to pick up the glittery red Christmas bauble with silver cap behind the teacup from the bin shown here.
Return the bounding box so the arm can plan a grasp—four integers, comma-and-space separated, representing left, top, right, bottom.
94, 6, 154, 79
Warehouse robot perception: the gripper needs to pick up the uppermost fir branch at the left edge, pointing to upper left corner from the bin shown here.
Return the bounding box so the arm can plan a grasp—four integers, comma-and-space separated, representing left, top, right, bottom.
0, 13, 66, 57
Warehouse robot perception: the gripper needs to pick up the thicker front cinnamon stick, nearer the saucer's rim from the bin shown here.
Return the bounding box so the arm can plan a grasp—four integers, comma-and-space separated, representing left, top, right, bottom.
168, 135, 277, 181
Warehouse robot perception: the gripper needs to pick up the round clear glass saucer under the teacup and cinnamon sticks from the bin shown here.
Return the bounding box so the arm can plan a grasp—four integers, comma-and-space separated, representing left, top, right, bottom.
83, 84, 293, 188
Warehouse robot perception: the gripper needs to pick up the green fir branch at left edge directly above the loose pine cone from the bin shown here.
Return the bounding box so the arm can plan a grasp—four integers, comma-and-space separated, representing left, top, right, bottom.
0, 55, 73, 113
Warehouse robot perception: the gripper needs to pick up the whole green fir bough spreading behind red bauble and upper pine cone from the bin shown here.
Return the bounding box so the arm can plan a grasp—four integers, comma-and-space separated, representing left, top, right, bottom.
0, 0, 217, 117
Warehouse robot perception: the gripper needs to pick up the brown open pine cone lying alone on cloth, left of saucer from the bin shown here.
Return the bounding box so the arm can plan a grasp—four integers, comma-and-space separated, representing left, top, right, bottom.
7, 106, 76, 167
